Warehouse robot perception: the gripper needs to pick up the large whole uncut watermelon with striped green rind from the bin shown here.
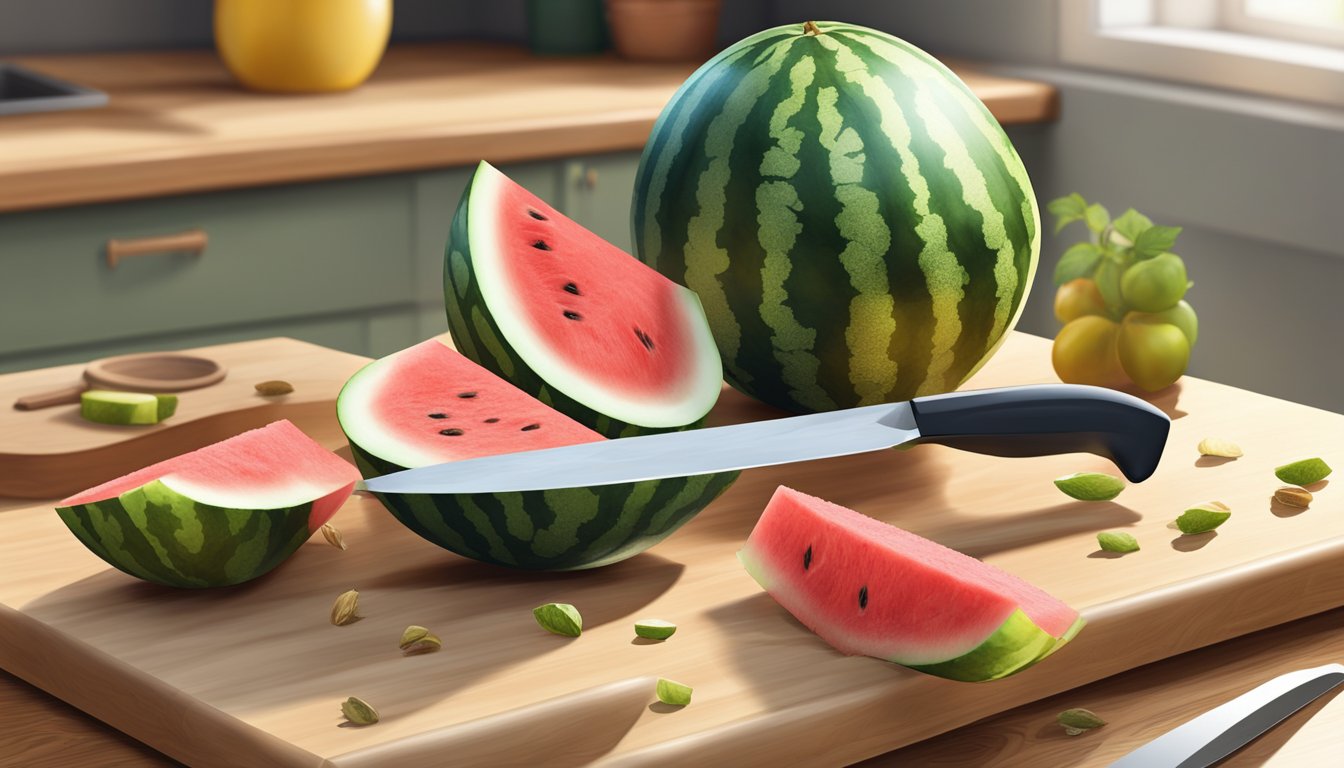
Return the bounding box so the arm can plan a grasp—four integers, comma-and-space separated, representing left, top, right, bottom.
632, 22, 1040, 412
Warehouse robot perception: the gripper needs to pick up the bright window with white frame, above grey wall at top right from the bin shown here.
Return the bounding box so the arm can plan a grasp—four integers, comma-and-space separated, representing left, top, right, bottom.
1059, 0, 1344, 106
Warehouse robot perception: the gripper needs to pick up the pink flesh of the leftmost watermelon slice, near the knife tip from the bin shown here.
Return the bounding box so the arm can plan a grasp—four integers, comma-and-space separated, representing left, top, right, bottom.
56, 420, 359, 531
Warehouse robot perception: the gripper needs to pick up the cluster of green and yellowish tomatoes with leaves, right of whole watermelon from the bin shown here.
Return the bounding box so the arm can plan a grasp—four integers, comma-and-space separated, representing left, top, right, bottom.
1050, 194, 1199, 391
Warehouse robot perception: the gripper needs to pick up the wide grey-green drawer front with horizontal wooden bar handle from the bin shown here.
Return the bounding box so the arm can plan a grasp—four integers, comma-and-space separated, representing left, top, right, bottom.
0, 176, 414, 356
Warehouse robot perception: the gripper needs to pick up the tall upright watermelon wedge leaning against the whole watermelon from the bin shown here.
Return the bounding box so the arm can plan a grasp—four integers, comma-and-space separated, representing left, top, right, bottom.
444, 163, 723, 437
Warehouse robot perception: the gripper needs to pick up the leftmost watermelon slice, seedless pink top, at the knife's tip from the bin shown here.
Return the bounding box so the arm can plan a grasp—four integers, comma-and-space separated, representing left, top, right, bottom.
56, 421, 359, 586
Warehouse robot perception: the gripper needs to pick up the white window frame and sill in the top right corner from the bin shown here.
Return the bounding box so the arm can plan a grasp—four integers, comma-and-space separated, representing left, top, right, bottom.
1059, 0, 1344, 106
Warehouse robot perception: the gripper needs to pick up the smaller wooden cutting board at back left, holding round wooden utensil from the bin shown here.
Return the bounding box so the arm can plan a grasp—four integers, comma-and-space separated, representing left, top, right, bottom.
0, 339, 368, 499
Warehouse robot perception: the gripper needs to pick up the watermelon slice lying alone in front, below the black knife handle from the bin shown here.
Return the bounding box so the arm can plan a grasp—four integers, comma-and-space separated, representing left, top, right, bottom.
738, 486, 1083, 682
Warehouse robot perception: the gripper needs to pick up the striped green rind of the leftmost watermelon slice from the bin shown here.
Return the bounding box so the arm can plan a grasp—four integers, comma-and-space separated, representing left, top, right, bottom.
56, 480, 313, 588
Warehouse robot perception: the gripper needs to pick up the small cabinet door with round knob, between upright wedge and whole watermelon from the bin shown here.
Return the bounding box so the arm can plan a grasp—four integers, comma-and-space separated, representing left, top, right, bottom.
559, 152, 640, 253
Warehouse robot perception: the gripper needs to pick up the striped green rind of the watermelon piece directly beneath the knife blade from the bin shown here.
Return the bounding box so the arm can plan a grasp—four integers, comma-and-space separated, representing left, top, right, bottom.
351, 440, 738, 570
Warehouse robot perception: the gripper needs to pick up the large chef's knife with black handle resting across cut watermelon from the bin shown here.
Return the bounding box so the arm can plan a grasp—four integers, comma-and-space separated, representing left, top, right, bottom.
363, 385, 1171, 494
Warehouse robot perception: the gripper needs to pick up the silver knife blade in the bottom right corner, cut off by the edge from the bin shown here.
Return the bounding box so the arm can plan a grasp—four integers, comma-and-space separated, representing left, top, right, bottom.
1111, 664, 1344, 768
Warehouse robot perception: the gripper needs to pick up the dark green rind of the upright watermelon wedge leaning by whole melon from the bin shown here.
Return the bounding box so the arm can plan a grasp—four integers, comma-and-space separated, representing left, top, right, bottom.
444, 162, 704, 438
